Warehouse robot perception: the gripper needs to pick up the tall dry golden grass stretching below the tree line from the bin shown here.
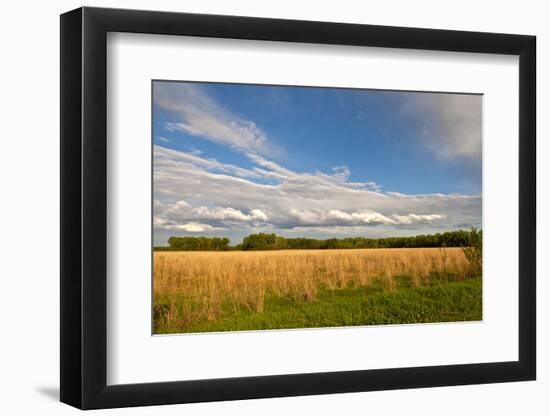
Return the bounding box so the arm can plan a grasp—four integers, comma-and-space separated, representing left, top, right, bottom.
153, 248, 471, 327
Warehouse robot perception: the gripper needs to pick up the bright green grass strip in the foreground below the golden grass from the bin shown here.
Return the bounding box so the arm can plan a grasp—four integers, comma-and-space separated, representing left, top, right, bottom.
154, 277, 482, 334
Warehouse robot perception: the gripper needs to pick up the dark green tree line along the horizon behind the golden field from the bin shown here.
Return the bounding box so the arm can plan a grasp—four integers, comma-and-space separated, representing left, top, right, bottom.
155, 228, 482, 251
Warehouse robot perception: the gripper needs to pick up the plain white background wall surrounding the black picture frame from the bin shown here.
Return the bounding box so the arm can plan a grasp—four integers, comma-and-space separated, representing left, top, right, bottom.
0, 0, 550, 417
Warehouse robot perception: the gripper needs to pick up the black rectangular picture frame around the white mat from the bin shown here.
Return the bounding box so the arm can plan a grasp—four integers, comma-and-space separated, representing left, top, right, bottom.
60, 7, 536, 409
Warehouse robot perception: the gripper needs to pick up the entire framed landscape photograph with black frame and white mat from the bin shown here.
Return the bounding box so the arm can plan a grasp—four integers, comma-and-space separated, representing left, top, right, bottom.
61, 7, 536, 409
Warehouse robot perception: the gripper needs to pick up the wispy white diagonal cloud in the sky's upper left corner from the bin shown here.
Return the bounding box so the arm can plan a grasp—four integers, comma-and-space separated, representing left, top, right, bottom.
153, 82, 274, 154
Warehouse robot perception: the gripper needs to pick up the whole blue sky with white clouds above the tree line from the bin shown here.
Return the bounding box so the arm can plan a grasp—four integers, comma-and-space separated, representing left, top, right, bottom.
153, 81, 482, 244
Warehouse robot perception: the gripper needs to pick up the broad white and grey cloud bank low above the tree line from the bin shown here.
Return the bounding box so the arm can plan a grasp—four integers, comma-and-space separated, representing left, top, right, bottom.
154, 146, 481, 240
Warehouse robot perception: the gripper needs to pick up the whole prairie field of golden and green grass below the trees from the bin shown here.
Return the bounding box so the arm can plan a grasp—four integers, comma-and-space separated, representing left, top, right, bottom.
153, 248, 481, 334
